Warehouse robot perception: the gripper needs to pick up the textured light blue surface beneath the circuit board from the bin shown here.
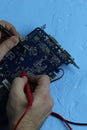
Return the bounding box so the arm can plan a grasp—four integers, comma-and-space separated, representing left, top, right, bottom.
0, 0, 87, 130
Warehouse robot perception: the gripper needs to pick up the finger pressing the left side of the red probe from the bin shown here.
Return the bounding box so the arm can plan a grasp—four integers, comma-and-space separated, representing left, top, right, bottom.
10, 77, 28, 104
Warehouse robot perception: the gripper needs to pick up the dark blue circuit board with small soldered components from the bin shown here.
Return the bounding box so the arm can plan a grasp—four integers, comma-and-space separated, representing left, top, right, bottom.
0, 28, 78, 124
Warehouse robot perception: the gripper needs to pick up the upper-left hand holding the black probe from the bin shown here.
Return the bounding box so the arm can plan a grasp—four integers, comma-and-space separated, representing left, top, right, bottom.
0, 20, 21, 61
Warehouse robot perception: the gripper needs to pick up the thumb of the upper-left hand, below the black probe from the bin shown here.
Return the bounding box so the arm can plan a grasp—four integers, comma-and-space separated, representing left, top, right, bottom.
0, 36, 19, 61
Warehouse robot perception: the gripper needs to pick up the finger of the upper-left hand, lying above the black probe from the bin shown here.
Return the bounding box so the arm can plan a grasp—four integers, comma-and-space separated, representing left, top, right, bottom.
0, 20, 22, 38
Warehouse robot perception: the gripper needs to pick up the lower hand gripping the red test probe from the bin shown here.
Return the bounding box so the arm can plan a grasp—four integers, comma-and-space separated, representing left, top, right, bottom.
7, 75, 53, 130
